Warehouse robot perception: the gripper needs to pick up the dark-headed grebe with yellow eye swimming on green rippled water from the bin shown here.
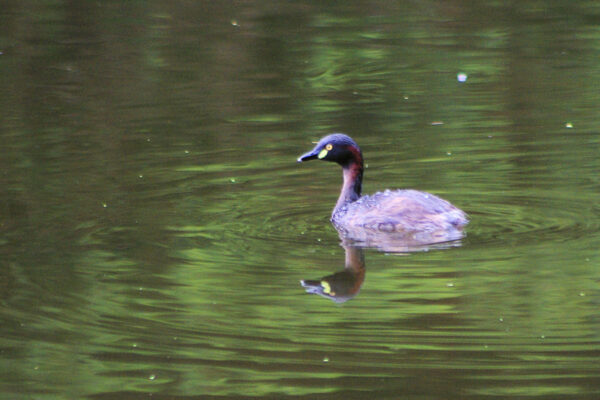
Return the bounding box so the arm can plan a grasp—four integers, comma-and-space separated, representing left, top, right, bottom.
298, 133, 469, 241
